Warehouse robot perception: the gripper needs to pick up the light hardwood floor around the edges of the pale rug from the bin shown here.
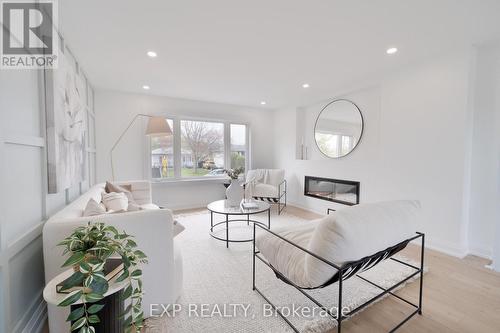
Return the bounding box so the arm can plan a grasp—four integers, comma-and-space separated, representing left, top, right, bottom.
46, 206, 500, 333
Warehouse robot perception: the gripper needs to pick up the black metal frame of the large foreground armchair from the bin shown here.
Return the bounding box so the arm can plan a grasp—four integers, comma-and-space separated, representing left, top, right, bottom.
252, 218, 425, 333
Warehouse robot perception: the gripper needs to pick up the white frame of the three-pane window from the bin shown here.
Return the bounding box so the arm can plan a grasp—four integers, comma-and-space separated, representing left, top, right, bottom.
145, 115, 251, 183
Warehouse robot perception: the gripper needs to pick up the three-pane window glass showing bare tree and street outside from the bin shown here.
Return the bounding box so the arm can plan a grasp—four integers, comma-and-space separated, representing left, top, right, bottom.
150, 119, 249, 180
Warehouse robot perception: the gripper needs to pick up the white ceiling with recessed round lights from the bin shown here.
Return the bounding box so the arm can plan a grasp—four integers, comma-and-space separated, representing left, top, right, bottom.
59, 0, 500, 108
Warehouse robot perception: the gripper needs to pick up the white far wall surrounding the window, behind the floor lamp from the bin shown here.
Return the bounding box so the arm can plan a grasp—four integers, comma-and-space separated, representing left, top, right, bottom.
96, 91, 273, 209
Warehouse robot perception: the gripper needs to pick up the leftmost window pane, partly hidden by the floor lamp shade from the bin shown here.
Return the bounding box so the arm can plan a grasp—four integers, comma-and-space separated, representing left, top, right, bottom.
151, 119, 174, 179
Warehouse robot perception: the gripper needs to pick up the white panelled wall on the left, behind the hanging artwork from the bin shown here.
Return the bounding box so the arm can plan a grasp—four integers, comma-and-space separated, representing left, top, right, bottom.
0, 48, 95, 333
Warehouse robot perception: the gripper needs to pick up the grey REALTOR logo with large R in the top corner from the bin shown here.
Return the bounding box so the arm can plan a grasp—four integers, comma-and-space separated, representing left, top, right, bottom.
0, 0, 59, 69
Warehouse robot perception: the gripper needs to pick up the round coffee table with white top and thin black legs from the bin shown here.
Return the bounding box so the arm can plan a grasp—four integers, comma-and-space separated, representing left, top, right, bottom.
207, 200, 271, 247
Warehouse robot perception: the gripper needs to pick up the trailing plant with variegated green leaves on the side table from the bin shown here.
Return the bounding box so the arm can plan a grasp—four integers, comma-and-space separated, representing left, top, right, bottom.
58, 222, 147, 333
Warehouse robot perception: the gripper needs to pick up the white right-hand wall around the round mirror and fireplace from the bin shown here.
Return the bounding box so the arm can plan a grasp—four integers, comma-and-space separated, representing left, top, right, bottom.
275, 51, 471, 256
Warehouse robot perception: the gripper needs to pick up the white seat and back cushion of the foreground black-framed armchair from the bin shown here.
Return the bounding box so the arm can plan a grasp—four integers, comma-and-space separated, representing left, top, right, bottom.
305, 201, 420, 287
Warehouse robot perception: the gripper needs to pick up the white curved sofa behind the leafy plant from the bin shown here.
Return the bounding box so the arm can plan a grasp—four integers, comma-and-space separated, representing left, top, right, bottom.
43, 181, 182, 333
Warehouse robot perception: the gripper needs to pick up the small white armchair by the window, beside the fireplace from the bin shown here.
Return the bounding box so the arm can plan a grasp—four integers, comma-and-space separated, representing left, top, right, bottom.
244, 169, 287, 214
